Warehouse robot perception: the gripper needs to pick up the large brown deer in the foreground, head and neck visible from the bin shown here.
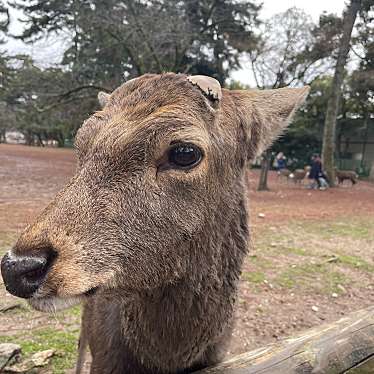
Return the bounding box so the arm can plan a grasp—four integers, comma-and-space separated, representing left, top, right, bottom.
1, 73, 309, 374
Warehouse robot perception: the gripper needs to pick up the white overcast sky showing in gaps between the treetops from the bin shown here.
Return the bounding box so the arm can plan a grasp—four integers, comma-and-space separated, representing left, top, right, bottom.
5, 0, 345, 85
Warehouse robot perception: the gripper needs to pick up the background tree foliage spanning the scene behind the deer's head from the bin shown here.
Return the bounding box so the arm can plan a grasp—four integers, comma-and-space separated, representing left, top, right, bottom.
0, 0, 374, 172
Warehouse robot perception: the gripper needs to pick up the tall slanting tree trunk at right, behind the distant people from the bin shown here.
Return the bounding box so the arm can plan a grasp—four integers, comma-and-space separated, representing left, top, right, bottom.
322, 0, 361, 186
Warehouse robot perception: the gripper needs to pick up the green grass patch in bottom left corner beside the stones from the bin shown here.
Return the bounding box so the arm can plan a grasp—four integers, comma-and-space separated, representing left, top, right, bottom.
0, 328, 79, 374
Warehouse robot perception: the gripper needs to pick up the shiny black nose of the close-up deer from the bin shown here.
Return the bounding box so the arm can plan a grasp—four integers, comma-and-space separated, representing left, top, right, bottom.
1, 252, 49, 299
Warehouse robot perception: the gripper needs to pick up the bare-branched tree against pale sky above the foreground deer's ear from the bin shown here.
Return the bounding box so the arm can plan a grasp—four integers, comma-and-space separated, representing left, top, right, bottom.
249, 8, 339, 191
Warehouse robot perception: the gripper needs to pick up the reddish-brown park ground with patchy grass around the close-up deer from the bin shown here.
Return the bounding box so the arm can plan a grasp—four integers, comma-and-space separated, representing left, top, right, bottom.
0, 145, 374, 373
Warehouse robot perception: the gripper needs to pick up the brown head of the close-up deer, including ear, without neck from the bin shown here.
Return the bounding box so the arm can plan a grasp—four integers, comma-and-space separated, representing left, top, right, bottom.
1, 74, 307, 311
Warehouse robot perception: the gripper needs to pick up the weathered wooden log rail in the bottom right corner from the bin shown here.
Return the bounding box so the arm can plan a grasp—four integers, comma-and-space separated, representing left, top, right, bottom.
198, 307, 374, 374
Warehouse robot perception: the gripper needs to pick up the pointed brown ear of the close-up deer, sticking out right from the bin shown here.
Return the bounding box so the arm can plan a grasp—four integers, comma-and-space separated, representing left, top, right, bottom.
231, 86, 310, 159
